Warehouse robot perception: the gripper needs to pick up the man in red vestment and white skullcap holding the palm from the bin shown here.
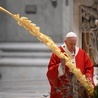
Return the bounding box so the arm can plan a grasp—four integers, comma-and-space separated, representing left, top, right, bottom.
47, 32, 94, 98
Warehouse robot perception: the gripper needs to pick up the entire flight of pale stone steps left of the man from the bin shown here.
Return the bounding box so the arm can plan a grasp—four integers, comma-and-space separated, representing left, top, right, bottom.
0, 43, 51, 98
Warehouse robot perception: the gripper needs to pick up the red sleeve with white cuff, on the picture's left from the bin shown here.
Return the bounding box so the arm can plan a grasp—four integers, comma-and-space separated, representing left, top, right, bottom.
47, 53, 63, 87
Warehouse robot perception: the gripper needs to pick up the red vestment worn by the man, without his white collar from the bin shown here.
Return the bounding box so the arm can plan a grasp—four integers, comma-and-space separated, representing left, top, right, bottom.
47, 46, 94, 98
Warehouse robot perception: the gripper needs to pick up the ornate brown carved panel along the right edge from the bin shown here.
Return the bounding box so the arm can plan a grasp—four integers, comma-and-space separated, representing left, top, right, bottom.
80, 2, 98, 64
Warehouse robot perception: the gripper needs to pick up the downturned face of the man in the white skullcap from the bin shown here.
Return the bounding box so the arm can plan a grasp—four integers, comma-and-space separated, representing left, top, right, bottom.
65, 37, 77, 52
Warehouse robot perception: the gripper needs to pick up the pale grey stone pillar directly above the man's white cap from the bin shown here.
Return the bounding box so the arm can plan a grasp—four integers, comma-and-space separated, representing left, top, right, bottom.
62, 0, 73, 39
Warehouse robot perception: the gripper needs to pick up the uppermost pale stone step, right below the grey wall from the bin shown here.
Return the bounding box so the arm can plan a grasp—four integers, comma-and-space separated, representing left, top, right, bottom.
0, 42, 49, 51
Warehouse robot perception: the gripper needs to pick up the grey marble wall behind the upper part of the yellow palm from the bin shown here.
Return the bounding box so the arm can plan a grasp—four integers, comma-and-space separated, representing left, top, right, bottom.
0, 0, 63, 42
